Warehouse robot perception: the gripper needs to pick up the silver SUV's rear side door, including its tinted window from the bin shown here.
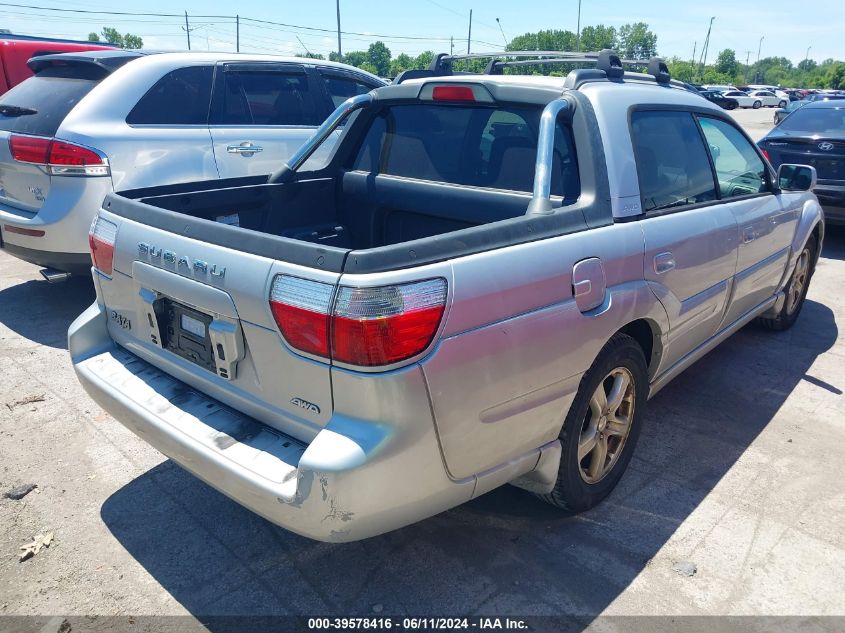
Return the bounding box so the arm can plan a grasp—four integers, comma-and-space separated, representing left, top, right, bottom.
210, 62, 328, 178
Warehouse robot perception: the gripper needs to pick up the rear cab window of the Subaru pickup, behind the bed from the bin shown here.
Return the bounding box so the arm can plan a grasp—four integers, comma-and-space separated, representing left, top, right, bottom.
353, 104, 581, 198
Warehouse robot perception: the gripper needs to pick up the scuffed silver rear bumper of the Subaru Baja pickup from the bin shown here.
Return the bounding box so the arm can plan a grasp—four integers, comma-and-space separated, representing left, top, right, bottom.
69, 304, 478, 542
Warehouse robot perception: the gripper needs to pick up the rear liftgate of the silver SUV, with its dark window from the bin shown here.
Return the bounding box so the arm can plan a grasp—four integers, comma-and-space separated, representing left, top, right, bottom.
0, 67, 102, 213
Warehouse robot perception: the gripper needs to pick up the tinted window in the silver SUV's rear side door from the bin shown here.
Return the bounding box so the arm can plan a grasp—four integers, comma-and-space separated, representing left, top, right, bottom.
212, 71, 322, 126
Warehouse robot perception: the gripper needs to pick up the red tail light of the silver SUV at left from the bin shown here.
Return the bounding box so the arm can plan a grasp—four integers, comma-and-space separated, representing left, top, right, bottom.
9, 134, 110, 176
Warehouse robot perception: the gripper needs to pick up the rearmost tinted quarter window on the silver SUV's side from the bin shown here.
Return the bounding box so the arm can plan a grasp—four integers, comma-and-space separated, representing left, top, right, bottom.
126, 66, 214, 125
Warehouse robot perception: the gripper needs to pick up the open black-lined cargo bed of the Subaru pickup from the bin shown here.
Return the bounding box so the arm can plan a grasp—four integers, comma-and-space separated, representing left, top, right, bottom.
105, 171, 585, 272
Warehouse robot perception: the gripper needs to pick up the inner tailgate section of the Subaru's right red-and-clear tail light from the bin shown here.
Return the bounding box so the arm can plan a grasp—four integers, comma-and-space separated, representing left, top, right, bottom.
270, 275, 334, 358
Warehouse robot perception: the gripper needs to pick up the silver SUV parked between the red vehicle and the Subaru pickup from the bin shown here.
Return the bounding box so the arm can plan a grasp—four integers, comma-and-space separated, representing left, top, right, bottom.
0, 51, 384, 279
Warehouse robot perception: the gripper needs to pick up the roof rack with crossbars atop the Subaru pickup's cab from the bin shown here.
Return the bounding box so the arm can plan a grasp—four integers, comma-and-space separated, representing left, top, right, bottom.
393, 48, 677, 85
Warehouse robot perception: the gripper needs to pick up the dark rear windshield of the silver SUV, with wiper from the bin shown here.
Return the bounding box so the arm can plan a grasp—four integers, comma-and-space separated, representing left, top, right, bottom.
0, 68, 102, 136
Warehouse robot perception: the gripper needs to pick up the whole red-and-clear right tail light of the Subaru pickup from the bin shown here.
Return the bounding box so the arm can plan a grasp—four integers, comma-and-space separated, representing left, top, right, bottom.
270, 275, 446, 367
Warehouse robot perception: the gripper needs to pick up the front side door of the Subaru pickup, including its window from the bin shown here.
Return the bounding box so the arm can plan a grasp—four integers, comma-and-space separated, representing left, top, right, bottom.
698, 116, 800, 325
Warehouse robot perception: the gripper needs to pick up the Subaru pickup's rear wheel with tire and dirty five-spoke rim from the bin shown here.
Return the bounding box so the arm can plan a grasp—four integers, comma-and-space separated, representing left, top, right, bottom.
538, 333, 648, 512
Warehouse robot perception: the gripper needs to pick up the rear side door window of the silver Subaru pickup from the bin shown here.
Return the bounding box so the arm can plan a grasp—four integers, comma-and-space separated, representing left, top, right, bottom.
631, 111, 716, 212
